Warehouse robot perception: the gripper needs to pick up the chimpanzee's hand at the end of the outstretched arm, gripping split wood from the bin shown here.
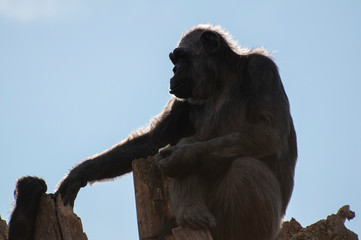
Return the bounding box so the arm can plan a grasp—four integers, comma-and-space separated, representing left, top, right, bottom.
55, 172, 87, 207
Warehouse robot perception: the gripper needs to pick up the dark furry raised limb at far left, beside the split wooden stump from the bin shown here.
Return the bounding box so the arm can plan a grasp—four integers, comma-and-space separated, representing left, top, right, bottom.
9, 177, 47, 240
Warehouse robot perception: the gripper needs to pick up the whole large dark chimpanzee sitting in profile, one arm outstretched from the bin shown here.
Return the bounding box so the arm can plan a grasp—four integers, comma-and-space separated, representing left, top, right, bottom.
58, 25, 297, 240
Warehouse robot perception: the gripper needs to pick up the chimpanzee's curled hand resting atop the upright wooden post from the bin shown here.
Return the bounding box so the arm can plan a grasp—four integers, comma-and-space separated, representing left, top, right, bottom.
154, 144, 196, 177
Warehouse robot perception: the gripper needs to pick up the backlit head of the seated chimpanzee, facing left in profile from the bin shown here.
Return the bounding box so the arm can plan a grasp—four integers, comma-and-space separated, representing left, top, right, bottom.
169, 25, 235, 100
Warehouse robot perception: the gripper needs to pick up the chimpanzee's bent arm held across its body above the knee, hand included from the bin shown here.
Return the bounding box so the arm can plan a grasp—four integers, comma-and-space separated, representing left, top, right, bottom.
155, 122, 282, 177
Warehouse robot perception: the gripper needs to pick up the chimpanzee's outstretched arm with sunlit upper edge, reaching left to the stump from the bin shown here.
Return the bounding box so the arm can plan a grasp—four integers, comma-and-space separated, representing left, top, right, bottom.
57, 99, 193, 206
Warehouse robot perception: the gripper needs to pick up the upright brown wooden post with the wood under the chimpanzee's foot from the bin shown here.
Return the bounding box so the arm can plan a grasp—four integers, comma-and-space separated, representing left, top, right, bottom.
132, 157, 212, 240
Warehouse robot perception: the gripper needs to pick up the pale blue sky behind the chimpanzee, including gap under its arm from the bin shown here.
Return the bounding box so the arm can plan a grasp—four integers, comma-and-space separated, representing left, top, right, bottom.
0, 0, 361, 239
